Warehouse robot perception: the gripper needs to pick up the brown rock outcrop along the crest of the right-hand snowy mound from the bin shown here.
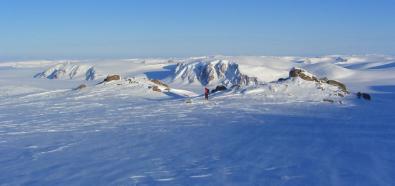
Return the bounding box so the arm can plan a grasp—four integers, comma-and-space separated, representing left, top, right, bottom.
289, 68, 349, 93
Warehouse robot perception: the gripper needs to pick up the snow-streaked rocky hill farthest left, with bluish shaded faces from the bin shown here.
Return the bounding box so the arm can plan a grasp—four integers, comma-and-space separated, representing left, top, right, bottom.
34, 63, 96, 81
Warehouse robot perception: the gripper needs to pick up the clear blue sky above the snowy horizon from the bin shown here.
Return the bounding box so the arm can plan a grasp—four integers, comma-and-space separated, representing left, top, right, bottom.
0, 0, 395, 59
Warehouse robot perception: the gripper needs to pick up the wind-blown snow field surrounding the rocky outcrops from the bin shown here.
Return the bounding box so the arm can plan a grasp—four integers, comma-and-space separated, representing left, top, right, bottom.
0, 55, 395, 186
